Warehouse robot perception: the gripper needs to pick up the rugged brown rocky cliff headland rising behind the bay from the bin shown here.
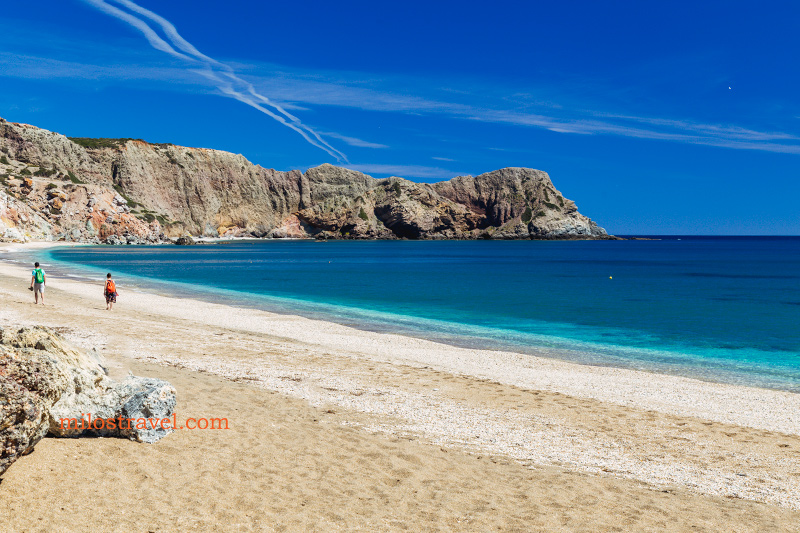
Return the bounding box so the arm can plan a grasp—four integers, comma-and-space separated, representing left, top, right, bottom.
0, 119, 608, 243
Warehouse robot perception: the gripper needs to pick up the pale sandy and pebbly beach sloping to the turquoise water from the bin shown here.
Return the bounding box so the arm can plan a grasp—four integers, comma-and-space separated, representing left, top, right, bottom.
0, 245, 800, 531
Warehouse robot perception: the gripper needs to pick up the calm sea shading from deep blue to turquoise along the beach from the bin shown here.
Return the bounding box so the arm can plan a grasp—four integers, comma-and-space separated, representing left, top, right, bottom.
29, 237, 800, 392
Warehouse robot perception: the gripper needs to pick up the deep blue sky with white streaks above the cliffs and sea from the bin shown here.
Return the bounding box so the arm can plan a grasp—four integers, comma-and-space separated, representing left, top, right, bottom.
0, 0, 800, 235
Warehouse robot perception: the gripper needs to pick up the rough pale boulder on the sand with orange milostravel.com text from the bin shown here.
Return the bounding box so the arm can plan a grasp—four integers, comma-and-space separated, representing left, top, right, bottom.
0, 327, 175, 474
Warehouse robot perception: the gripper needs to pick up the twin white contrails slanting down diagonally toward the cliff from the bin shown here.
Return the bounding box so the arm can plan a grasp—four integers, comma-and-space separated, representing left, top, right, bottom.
77, 0, 348, 162
